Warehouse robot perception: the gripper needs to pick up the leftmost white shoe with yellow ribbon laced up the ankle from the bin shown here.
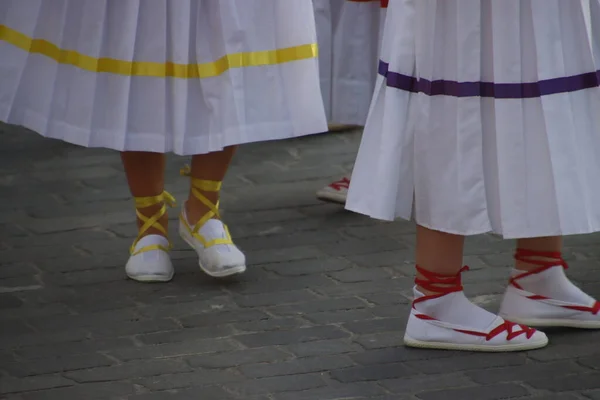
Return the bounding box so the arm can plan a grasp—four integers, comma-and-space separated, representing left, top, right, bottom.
125, 192, 175, 282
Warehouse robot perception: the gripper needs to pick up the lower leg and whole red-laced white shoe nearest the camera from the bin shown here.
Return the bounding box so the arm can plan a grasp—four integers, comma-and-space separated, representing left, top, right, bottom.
404, 226, 547, 351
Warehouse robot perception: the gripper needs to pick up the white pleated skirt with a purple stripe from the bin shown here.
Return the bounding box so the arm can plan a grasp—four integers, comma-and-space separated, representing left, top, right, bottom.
347, 0, 600, 238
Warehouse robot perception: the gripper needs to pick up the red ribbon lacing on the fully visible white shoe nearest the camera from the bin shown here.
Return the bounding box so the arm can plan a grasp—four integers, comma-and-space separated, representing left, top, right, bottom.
412, 265, 536, 341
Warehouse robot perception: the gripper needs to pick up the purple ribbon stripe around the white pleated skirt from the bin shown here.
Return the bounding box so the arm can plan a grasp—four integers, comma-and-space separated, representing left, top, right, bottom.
379, 61, 600, 99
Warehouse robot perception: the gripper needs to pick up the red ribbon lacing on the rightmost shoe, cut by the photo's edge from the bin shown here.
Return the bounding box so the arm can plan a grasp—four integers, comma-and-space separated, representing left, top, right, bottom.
509, 249, 600, 315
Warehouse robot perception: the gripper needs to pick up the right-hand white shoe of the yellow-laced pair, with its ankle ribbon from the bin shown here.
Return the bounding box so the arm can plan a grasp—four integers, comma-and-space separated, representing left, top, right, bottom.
179, 167, 246, 278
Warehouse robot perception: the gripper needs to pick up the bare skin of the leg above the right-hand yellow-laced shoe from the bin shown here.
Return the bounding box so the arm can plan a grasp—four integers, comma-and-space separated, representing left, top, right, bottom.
185, 146, 237, 224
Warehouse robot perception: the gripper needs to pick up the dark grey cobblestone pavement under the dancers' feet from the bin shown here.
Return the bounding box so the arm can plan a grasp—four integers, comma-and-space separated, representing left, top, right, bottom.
0, 125, 600, 400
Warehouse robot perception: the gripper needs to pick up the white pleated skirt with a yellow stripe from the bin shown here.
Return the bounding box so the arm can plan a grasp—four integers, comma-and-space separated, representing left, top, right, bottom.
0, 0, 327, 155
